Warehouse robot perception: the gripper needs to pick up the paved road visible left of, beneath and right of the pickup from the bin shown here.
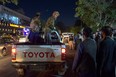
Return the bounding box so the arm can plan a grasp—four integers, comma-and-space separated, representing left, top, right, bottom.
0, 46, 75, 77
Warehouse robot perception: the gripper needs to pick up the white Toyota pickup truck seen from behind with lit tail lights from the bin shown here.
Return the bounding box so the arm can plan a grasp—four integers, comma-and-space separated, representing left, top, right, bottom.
12, 31, 67, 76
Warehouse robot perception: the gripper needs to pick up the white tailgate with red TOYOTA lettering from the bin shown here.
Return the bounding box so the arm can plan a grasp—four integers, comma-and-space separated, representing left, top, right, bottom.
12, 45, 65, 62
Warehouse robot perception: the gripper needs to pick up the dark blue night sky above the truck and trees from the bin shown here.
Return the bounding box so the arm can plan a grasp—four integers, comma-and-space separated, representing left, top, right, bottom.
6, 0, 77, 26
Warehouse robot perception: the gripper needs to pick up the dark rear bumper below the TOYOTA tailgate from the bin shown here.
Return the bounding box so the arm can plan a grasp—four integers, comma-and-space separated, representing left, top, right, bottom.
12, 62, 66, 70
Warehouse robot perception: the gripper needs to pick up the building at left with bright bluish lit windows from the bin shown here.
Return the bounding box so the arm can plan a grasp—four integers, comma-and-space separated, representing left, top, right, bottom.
0, 5, 30, 35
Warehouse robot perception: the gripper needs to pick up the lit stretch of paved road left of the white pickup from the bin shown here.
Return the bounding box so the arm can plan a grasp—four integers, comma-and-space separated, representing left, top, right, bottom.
0, 55, 18, 77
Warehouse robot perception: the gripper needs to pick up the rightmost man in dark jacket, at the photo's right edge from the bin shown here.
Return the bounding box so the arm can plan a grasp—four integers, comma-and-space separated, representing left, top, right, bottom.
96, 26, 116, 77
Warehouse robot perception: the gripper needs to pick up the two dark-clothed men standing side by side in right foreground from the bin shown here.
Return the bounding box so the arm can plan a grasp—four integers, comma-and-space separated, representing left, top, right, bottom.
72, 26, 116, 77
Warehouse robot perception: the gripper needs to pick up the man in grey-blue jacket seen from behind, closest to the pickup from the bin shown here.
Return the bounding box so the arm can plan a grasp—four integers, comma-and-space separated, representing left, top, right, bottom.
72, 27, 97, 77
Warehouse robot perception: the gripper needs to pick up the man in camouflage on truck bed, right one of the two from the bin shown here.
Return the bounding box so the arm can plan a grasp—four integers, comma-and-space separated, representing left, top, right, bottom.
45, 11, 60, 43
